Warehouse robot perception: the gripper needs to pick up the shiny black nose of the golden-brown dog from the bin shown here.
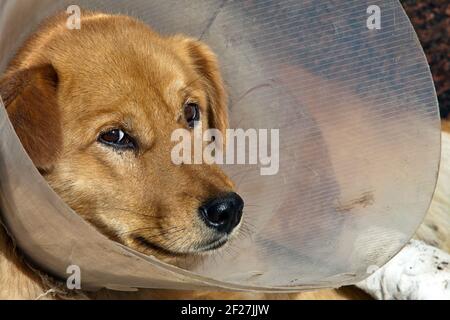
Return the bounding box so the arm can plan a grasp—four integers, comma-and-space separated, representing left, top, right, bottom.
200, 192, 244, 233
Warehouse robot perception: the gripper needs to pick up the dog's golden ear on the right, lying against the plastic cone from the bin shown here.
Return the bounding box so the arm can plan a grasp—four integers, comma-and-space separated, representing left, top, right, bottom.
176, 36, 228, 137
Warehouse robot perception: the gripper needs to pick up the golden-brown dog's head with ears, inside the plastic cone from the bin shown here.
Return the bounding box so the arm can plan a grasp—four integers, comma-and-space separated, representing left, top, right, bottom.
0, 14, 243, 259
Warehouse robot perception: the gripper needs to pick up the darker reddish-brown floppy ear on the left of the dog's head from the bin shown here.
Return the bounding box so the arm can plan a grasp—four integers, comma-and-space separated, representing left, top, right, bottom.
0, 64, 62, 171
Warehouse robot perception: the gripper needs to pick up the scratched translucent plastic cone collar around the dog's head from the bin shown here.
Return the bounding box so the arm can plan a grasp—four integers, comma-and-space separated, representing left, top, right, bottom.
0, 0, 440, 291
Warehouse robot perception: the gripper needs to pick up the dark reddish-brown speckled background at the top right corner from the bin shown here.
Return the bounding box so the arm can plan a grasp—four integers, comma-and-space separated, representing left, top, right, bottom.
400, 0, 450, 119
